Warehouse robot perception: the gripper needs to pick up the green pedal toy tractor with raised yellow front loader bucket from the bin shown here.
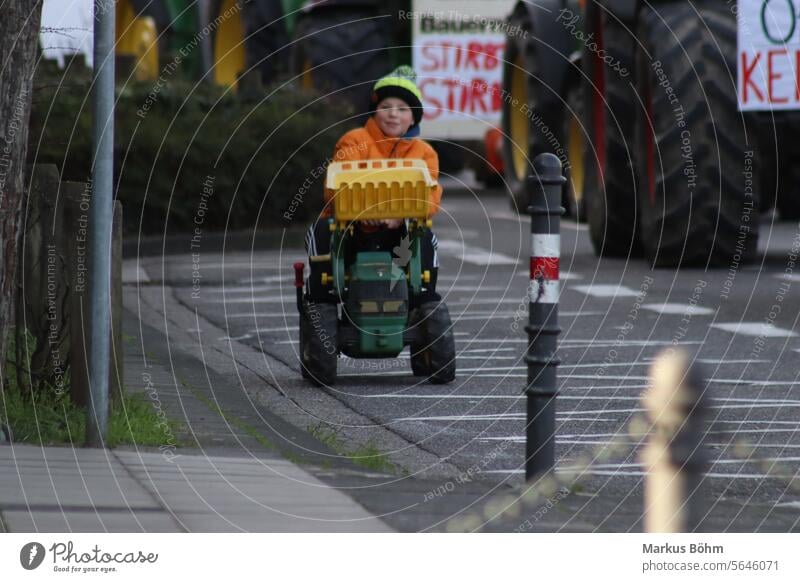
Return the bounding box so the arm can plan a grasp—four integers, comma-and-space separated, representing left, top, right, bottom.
294, 159, 456, 386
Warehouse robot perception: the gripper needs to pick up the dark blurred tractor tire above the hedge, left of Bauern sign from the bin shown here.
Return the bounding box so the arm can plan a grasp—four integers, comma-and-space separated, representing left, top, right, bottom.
291, 6, 392, 111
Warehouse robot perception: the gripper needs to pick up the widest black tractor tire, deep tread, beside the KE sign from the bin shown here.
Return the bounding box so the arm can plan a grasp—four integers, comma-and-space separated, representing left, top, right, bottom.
636, 0, 759, 267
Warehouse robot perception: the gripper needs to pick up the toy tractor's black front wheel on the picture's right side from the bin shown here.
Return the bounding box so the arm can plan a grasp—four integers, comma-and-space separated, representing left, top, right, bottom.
411, 302, 456, 384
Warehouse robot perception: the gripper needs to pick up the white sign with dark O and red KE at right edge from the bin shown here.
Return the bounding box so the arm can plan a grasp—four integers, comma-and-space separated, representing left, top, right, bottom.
737, 0, 800, 111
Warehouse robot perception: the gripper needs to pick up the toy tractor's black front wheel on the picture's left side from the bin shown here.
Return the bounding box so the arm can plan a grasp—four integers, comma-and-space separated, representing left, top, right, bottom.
299, 303, 339, 386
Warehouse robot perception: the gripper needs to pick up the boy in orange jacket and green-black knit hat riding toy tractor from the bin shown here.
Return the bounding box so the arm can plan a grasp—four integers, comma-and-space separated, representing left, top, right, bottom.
306, 65, 442, 307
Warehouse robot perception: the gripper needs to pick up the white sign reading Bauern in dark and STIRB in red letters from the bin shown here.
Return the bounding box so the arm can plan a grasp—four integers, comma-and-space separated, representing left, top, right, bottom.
410, 0, 515, 139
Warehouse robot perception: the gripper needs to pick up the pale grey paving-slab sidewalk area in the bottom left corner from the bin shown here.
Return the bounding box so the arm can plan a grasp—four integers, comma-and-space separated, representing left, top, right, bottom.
0, 445, 389, 532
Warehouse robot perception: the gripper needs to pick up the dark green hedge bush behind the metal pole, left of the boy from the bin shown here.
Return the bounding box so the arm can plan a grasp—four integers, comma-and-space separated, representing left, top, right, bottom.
29, 64, 356, 234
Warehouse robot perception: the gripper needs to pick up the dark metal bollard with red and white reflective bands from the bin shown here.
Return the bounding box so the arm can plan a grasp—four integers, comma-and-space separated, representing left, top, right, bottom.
525, 154, 565, 480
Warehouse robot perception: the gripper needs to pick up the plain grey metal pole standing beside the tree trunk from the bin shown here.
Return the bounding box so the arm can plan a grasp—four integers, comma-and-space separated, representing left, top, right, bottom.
86, 0, 115, 447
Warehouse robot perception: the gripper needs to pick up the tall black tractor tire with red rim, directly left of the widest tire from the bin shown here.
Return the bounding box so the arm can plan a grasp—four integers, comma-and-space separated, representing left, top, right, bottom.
582, 1, 638, 257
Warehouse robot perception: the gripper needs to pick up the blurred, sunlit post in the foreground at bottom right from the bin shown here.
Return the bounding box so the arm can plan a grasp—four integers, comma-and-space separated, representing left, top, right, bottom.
642, 350, 707, 533
